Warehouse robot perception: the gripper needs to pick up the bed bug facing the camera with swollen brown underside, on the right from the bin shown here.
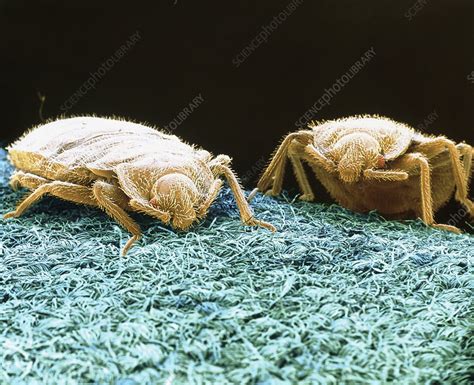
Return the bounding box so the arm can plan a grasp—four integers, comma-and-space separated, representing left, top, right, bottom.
249, 115, 474, 232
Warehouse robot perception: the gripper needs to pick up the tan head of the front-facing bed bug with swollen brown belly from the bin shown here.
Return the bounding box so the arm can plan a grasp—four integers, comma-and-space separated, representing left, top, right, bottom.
332, 132, 385, 183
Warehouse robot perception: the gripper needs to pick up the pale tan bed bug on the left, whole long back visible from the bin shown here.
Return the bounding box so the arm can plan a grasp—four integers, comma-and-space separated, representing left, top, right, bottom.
4, 116, 275, 254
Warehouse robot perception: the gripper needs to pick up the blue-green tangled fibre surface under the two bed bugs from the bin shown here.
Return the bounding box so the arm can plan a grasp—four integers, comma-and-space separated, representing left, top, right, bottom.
0, 151, 474, 385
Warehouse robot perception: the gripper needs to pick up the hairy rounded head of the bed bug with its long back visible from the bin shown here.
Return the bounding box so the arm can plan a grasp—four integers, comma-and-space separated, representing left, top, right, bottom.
150, 173, 199, 230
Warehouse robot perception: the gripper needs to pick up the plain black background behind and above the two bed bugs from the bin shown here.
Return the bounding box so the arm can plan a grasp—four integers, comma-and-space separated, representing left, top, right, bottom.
0, 0, 474, 225
